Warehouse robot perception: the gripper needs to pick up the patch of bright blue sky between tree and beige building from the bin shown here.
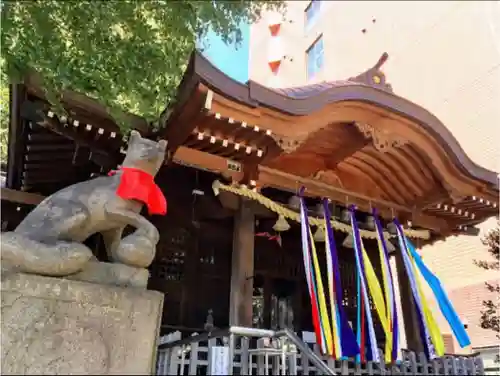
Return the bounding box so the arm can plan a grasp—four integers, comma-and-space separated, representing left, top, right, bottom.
203, 22, 250, 83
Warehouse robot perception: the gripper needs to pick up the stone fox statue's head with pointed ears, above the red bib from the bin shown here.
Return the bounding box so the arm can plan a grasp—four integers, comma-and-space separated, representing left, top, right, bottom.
122, 131, 167, 176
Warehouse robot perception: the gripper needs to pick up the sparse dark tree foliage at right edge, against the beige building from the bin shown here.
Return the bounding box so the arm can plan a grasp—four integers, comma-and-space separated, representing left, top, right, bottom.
475, 222, 500, 338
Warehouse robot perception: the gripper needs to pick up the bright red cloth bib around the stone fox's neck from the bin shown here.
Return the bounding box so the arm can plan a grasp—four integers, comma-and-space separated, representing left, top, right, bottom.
109, 167, 167, 215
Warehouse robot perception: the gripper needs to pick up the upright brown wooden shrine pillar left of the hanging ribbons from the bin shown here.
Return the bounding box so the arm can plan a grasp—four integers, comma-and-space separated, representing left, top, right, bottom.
229, 197, 255, 327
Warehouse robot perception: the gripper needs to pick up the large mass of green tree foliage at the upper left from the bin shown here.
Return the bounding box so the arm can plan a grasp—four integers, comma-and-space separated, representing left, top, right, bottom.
1, 0, 284, 128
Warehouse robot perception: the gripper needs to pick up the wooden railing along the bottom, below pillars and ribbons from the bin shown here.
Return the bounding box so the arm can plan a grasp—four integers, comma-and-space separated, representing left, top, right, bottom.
156, 327, 484, 376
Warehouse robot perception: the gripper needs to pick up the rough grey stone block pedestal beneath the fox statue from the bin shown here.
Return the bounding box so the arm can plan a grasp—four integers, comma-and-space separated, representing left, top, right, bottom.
1, 273, 163, 375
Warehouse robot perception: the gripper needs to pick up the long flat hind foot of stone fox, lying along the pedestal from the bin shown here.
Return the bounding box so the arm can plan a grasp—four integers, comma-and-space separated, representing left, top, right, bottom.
0, 232, 93, 277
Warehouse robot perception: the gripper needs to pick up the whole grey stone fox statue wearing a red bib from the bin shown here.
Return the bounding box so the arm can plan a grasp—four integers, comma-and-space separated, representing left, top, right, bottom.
1, 131, 167, 276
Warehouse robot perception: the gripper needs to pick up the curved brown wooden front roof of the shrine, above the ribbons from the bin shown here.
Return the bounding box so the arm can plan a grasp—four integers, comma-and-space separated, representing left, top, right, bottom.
160, 52, 498, 233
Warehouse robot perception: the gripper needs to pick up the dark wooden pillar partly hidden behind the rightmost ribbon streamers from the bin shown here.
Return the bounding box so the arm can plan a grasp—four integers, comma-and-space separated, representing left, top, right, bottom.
394, 250, 424, 353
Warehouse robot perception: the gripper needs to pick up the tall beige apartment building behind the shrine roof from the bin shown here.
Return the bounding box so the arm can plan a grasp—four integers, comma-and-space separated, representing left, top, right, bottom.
249, 0, 500, 353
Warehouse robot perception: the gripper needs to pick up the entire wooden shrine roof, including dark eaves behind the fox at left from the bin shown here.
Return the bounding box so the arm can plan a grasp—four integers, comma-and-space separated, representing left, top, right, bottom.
7, 52, 498, 235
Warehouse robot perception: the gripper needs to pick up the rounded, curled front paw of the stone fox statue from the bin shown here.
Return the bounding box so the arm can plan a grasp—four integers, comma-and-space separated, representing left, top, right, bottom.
113, 229, 158, 268
